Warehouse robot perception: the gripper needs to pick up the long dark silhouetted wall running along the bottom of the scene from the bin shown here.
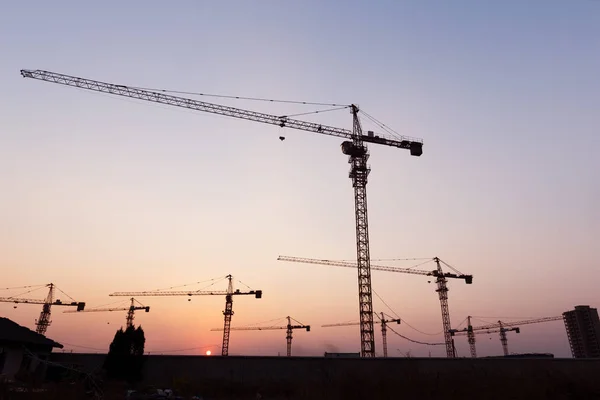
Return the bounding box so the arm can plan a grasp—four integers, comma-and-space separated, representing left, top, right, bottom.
52, 353, 600, 400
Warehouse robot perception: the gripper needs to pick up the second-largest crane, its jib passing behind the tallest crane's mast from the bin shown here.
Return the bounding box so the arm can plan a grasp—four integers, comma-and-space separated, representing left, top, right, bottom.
277, 256, 473, 358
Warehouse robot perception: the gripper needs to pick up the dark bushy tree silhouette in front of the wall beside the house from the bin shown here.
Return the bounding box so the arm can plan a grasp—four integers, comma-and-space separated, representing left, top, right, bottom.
103, 326, 146, 383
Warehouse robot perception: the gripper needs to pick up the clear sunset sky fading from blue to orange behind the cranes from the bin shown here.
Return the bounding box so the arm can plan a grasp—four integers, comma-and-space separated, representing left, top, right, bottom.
0, 0, 600, 356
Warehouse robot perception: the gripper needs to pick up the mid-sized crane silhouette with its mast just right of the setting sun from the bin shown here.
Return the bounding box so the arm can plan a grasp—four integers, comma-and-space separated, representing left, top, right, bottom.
109, 275, 262, 356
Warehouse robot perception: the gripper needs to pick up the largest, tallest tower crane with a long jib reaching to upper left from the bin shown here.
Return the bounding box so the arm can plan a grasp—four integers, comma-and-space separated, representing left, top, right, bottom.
21, 69, 423, 357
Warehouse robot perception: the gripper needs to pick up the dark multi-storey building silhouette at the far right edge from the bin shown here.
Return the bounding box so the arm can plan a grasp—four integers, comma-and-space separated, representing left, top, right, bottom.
563, 306, 600, 358
